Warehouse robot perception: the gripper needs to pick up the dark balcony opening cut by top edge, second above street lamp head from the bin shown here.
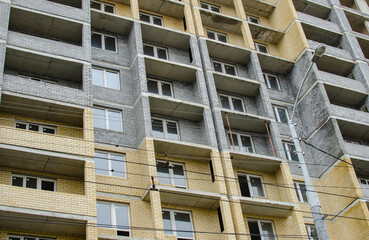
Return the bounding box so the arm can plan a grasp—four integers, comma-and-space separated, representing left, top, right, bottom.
293, 0, 330, 21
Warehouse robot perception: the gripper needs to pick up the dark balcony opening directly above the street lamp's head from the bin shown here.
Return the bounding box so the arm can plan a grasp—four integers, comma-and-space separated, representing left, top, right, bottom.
301, 23, 342, 48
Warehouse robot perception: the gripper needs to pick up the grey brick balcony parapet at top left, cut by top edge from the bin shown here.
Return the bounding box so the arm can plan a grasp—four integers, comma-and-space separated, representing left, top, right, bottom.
12, 0, 90, 22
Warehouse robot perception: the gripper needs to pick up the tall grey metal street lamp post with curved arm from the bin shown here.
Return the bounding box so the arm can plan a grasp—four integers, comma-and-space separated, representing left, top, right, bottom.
288, 44, 329, 240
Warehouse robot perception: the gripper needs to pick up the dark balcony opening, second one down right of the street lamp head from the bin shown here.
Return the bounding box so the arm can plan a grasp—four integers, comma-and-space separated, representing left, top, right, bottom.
324, 84, 367, 111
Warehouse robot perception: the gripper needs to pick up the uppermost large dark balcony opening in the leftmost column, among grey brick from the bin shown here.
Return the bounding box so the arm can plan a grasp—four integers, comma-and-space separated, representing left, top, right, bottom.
9, 8, 83, 46
